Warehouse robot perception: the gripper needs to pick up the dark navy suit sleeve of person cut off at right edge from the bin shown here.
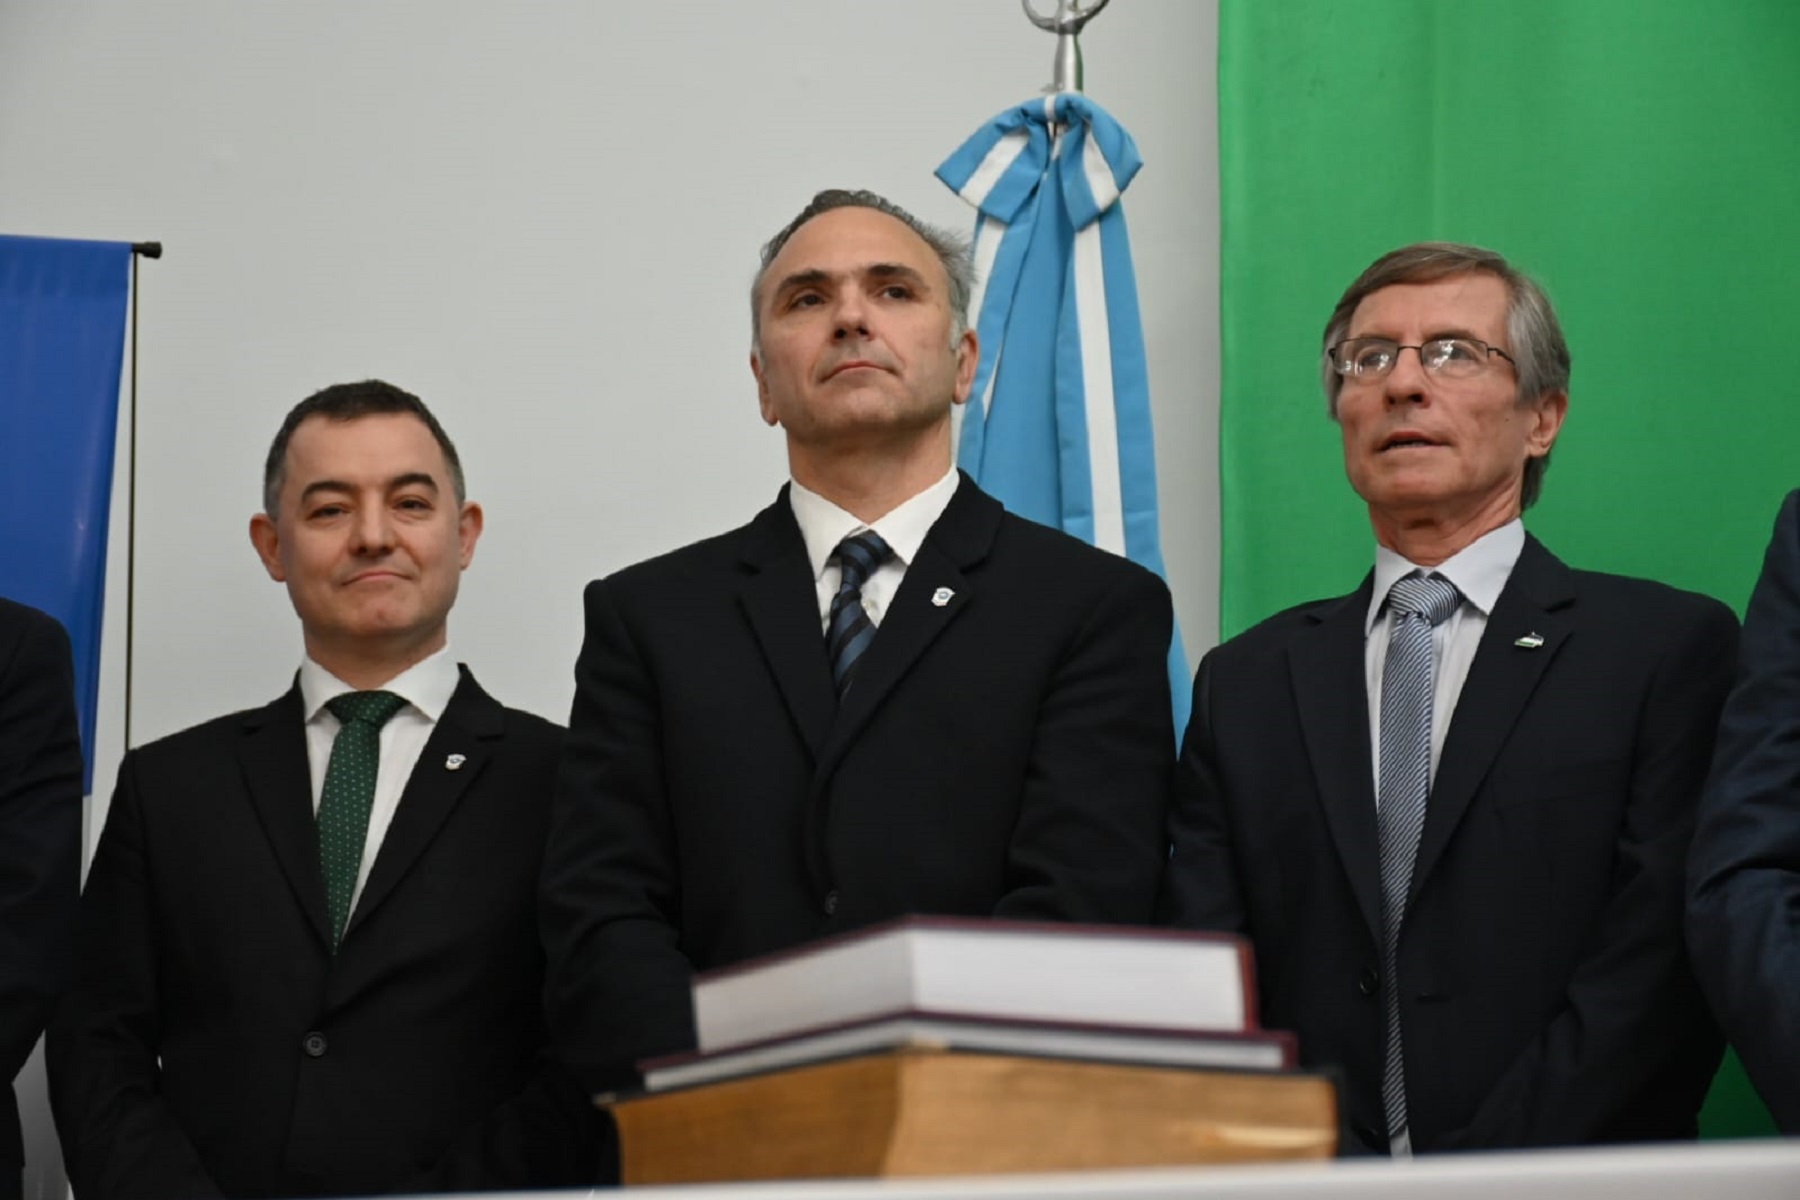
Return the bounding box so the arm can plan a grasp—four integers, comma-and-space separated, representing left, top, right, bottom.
1688, 491, 1800, 1133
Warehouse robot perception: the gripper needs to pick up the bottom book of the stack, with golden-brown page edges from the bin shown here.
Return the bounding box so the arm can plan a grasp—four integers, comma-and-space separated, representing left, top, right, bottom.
610, 1051, 1337, 1184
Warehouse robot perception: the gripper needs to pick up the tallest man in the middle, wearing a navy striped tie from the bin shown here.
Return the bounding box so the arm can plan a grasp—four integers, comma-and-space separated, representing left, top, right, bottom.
542, 191, 1174, 1088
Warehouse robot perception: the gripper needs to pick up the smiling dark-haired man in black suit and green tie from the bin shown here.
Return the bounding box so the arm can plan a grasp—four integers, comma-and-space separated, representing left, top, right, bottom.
49, 381, 607, 1200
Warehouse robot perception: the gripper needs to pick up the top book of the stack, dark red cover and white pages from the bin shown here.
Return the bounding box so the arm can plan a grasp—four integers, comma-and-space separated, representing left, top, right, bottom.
693, 918, 1256, 1054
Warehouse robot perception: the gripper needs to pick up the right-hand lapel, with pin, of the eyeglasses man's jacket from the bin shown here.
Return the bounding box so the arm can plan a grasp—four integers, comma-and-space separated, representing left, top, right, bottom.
1409, 536, 1575, 898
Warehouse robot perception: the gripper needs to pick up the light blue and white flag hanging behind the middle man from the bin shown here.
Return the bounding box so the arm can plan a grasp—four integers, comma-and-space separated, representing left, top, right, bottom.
938, 92, 1192, 739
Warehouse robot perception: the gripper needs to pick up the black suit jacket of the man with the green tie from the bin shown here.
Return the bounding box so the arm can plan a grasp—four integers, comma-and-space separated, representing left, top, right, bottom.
49, 671, 598, 1200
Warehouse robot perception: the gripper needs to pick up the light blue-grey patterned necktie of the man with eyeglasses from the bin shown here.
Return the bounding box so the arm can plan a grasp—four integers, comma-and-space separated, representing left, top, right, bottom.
1375, 570, 1462, 1137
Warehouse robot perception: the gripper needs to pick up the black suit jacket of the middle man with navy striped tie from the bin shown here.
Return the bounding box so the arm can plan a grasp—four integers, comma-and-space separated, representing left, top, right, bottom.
544, 477, 1174, 1087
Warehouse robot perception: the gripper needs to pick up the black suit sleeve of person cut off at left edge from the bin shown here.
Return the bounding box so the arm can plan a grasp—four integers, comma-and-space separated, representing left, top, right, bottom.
0, 599, 81, 1191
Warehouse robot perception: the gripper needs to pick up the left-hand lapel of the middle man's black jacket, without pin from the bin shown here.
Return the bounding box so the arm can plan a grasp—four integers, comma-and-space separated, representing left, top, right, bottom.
738, 488, 838, 763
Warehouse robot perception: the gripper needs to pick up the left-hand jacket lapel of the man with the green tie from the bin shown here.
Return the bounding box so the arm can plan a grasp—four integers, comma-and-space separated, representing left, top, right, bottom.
238, 684, 329, 945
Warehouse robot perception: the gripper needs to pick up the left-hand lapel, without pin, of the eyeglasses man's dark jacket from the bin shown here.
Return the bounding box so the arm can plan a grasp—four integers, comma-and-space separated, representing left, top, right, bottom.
1287, 578, 1381, 939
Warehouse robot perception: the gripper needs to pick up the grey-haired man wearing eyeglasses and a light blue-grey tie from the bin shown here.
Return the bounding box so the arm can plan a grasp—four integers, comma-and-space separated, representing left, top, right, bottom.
1163, 243, 1737, 1155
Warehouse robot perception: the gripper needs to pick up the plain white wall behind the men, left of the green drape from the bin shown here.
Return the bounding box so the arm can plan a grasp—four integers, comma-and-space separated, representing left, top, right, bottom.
0, 0, 1219, 1194
